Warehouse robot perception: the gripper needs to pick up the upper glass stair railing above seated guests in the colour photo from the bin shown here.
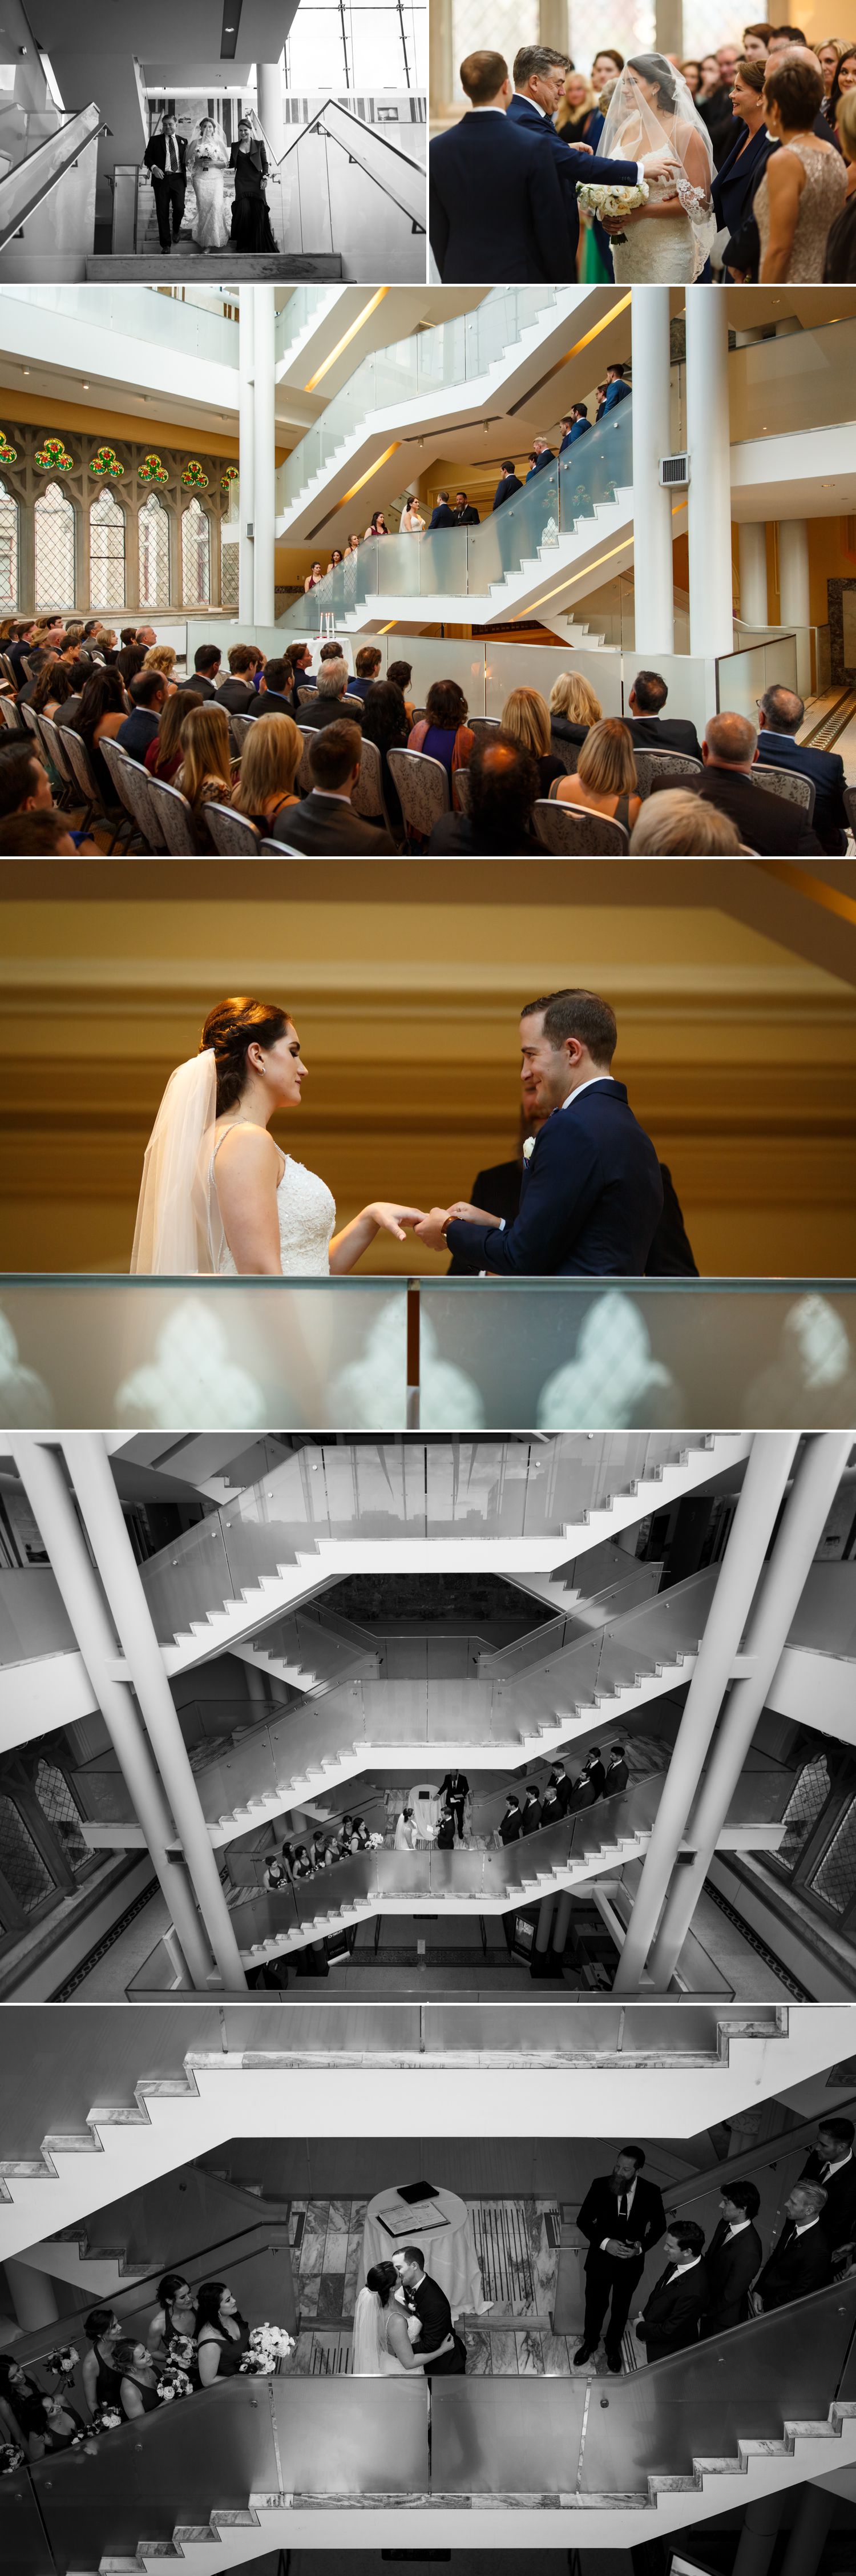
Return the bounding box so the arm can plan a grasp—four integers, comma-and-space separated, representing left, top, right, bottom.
276, 283, 557, 510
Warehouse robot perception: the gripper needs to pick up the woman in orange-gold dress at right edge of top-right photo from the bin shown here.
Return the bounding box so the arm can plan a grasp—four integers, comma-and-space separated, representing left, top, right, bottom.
756, 54, 846, 286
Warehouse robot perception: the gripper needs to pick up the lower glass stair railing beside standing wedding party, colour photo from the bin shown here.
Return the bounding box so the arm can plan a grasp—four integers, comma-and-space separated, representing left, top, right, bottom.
284, 399, 634, 634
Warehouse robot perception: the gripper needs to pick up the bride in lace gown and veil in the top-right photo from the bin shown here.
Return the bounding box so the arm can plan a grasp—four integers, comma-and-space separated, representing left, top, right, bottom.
598, 54, 717, 286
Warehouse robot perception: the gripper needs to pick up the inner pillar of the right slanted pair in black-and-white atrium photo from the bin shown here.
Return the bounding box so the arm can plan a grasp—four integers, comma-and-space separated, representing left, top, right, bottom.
613, 1432, 800, 1994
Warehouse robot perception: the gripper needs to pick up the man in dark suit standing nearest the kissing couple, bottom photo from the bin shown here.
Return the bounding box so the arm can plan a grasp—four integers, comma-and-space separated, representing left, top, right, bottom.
575, 2146, 665, 2373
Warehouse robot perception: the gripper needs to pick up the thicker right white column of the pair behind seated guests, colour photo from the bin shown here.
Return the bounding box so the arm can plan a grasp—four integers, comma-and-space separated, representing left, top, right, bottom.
685, 288, 735, 657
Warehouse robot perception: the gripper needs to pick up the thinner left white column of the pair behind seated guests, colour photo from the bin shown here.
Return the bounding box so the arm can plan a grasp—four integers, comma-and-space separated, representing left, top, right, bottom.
632, 286, 676, 659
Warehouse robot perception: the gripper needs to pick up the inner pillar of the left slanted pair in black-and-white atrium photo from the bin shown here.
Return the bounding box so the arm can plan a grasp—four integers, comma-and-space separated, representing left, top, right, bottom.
62, 1432, 248, 1994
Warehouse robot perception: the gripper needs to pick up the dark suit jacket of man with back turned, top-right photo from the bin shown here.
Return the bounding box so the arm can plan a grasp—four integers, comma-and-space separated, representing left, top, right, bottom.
428, 116, 578, 286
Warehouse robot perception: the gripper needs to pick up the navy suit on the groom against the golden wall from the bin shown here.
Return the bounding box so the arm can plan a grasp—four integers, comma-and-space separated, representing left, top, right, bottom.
446, 1074, 663, 1278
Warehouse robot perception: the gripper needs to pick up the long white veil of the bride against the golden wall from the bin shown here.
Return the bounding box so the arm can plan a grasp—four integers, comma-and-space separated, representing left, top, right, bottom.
131, 1046, 224, 1278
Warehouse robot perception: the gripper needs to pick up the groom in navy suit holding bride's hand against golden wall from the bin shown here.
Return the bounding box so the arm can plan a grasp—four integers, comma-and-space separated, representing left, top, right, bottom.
425, 992, 663, 1278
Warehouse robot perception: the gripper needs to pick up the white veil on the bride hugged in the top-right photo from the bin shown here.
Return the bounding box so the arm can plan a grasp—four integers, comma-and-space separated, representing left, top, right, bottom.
598, 54, 717, 276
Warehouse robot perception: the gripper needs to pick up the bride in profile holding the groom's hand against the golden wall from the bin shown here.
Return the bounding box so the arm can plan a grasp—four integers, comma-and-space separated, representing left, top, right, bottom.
131, 1000, 423, 1278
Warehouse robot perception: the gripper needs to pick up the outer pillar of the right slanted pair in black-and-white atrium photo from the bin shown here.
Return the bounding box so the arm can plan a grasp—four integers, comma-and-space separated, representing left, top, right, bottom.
650, 1432, 853, 1991
